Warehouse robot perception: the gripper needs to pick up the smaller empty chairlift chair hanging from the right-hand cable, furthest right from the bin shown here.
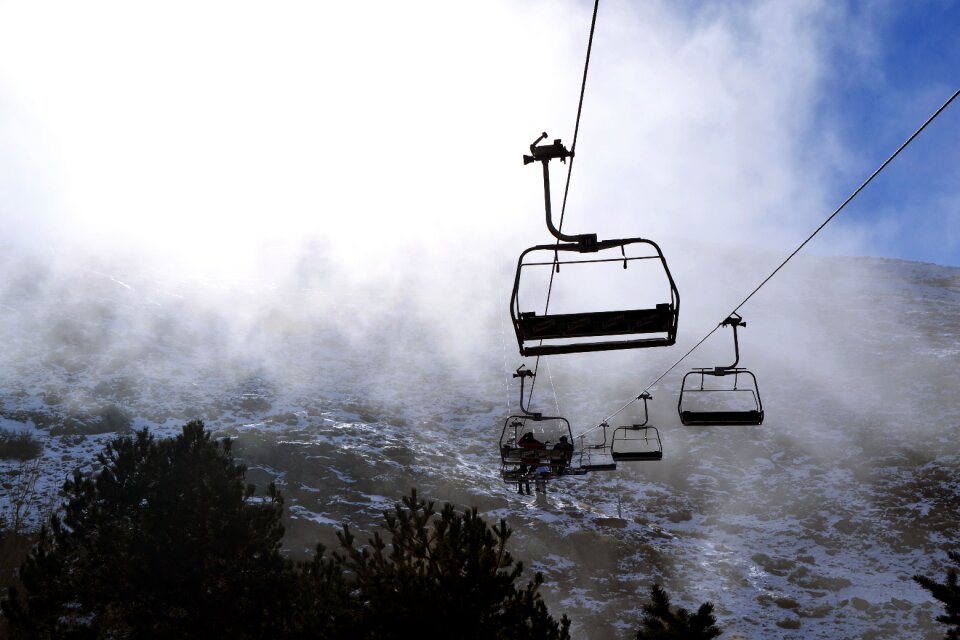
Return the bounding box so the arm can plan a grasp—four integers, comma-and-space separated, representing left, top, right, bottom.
677, 313, 763, 425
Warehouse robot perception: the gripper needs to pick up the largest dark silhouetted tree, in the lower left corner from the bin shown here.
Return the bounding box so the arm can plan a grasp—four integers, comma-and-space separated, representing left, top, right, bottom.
3, 421, 292, 638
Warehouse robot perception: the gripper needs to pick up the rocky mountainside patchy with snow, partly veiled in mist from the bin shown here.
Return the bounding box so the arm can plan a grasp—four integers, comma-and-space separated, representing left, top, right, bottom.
0, 248, 960, 640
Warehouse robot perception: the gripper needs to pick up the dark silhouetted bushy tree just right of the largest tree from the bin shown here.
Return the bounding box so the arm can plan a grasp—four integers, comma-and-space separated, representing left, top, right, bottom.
298, 490, 570, 640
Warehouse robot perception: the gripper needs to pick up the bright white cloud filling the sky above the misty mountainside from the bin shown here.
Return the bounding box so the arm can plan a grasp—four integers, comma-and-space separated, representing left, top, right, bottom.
0, 1, 948, 280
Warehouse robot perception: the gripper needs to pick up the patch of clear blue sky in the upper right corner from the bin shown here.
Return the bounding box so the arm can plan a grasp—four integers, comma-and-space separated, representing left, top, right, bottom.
808, 0, 960, 265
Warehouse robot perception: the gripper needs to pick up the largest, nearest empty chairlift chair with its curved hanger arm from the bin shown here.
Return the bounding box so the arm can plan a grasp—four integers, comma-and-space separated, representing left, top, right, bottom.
510, 133, 680, 356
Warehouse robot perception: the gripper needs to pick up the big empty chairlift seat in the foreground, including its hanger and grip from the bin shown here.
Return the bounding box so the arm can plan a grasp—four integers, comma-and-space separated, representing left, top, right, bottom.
510, 134, 680, 356
